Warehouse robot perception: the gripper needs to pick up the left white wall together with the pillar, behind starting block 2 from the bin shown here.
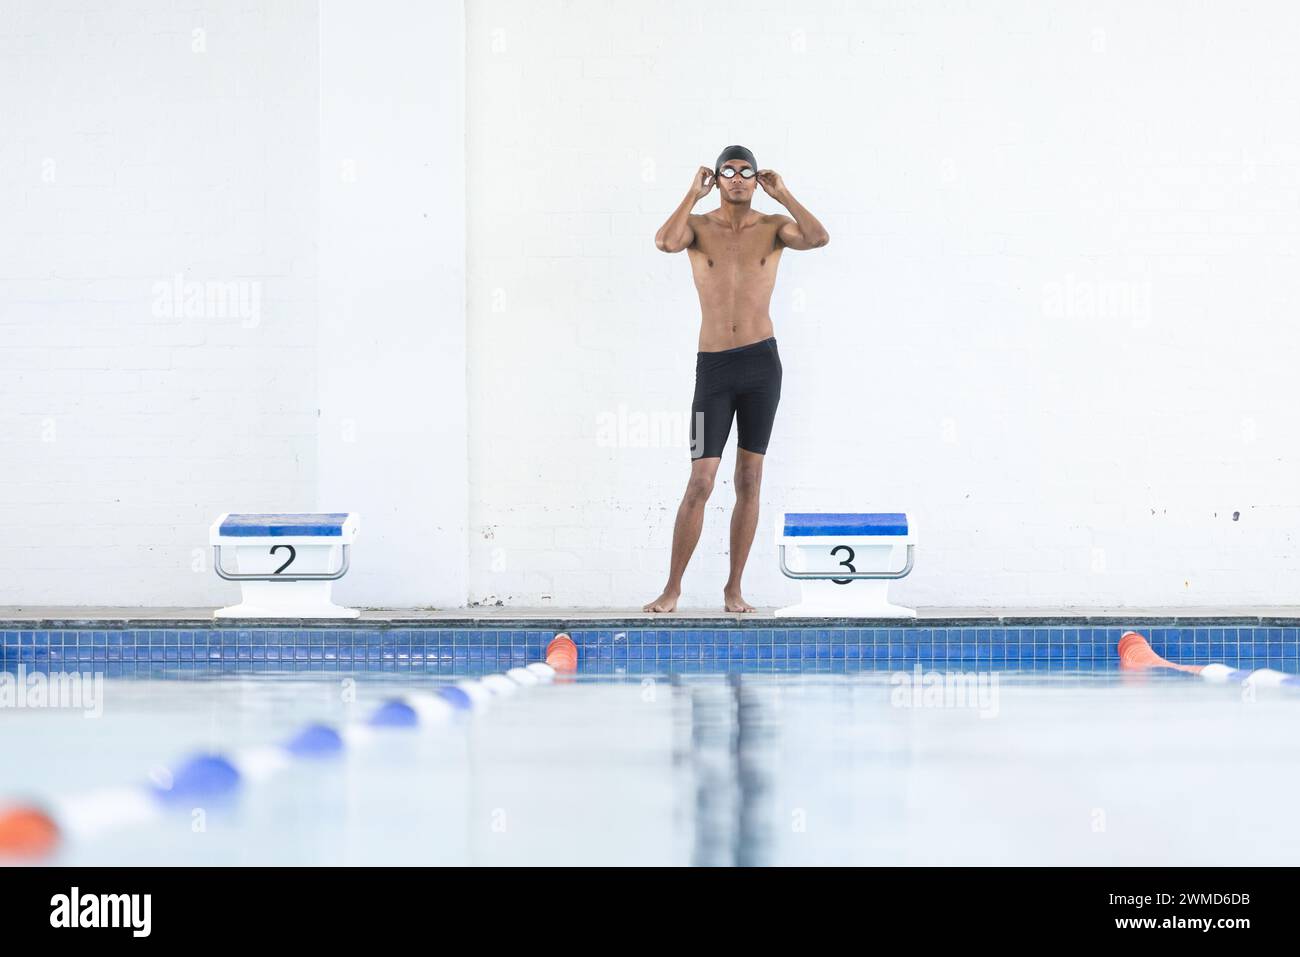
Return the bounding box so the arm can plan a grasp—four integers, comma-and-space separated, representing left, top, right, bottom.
0, 0, 465, 606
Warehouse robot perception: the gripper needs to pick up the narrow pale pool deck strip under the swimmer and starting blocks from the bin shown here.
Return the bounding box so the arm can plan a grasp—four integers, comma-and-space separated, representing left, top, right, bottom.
0, 605, 1300, 629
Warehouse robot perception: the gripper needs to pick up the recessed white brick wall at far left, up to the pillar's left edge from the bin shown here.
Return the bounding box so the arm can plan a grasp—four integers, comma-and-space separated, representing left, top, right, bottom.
0, 0, 319, 605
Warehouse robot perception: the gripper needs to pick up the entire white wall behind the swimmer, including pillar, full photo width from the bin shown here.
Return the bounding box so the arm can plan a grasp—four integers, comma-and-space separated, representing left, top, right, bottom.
0, 0, 1300, 606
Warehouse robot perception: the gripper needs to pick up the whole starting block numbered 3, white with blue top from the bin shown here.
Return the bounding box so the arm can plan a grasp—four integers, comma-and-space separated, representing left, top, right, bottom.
776, 512, 917, 618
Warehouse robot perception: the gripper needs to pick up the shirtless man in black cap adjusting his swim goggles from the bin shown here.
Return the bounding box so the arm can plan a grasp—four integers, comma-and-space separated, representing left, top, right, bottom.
642, 146, 831, 611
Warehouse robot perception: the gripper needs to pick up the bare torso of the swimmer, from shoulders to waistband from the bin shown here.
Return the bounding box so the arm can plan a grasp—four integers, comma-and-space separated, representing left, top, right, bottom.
686, 212, 785, 352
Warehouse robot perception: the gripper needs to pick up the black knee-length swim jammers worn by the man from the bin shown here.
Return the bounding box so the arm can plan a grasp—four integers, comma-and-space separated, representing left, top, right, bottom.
690, 337, 781, 459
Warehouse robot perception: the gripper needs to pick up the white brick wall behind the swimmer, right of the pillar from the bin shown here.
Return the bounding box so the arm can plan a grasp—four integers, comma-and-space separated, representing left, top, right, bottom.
467, 0, 1300, 606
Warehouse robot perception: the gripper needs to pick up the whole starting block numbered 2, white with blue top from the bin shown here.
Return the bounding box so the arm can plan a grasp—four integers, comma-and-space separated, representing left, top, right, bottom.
209, 512, 361, 618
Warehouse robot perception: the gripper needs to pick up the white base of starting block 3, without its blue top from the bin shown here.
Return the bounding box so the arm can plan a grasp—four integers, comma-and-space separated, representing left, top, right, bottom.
775, 515, 917, 618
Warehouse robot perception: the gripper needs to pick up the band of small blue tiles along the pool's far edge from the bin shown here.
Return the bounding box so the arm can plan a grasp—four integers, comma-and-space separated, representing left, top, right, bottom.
0, 620, 1300, 676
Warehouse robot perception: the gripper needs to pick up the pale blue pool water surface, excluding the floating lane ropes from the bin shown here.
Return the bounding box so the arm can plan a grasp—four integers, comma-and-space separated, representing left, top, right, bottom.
0, 670, 1300, 865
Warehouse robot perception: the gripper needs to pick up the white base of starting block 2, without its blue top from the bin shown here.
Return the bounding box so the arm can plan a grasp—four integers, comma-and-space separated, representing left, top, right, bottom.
212, 515, 361, 618
